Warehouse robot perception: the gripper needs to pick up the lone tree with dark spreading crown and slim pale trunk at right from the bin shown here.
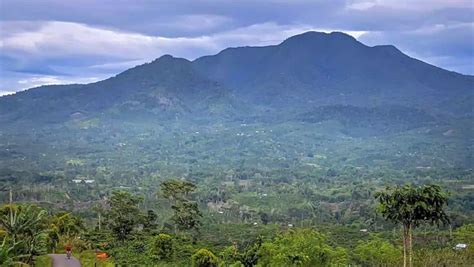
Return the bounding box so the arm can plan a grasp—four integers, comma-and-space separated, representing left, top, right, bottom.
375, 185, 449, 267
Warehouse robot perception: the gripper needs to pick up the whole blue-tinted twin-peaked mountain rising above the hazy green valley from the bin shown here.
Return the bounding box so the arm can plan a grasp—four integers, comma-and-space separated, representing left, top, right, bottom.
0, 32, 474, 127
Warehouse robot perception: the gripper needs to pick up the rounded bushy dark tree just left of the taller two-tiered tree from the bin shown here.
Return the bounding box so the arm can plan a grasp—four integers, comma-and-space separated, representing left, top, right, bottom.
106, 191, 142, 241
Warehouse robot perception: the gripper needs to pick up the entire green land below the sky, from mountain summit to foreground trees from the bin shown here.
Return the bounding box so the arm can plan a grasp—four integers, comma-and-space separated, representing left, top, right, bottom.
0, 32, 474, 266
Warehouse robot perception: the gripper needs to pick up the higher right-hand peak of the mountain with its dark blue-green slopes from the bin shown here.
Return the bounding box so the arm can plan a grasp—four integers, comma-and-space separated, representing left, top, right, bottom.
193, 32, 474, 112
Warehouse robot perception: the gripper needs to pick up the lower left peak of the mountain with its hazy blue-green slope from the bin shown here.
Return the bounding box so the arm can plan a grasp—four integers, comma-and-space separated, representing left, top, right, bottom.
0, 55, 236, 122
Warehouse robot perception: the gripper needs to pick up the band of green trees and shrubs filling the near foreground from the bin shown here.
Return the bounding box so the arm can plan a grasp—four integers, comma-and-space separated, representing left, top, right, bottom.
0, 180, 474, 266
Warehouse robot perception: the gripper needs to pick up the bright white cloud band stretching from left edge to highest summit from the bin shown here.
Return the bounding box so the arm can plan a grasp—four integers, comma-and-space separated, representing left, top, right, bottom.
0, 21, 363, 59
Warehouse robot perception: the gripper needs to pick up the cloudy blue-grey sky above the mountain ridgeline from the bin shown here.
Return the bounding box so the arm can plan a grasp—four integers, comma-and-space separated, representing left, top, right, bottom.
0, 0, 474, 95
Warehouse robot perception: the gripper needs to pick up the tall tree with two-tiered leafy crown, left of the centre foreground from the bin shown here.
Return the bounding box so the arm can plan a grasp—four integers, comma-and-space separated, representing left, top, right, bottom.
161, 180, 202, 234
